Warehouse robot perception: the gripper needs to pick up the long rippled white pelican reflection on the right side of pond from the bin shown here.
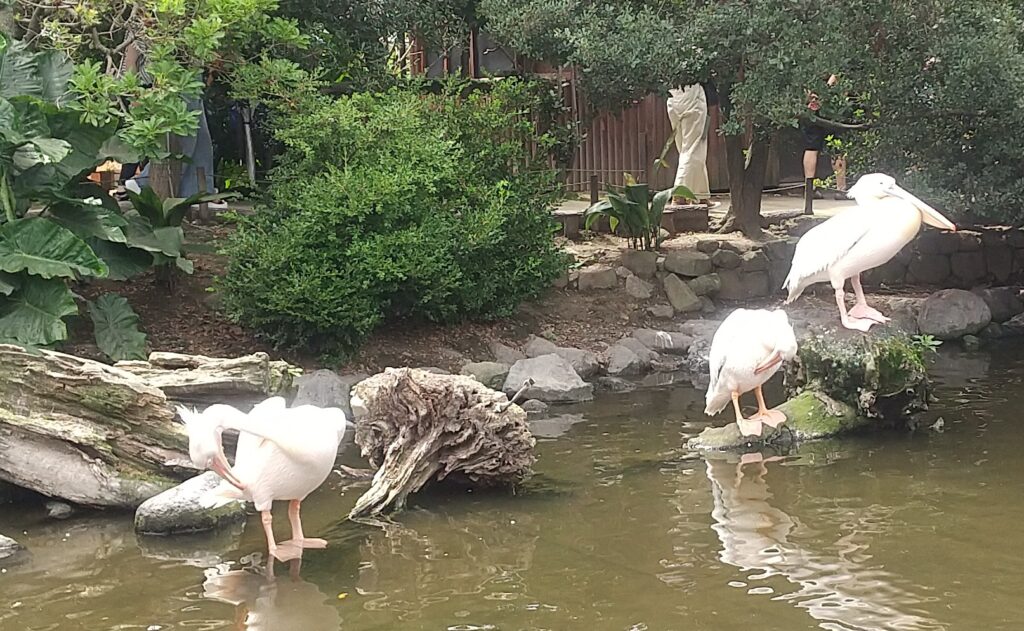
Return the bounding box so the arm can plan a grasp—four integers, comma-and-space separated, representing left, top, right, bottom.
706, 454, 945, 631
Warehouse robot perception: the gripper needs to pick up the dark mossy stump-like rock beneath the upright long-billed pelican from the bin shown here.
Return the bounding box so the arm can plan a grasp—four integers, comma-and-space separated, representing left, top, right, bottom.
785, 331, 930, 425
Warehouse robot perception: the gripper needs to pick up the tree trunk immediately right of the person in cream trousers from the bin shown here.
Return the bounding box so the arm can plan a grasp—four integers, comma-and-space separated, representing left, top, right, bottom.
719, 135, 771, 237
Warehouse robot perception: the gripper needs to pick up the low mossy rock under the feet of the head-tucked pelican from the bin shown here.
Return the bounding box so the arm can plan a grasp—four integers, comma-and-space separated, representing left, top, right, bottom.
686, 390, 871, 453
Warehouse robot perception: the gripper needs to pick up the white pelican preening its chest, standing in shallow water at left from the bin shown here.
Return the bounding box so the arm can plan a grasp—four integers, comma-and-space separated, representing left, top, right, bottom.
178, 396, 347, 560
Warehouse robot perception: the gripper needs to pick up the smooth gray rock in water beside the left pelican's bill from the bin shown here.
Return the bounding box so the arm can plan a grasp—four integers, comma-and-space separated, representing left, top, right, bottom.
135, 471, 246, 535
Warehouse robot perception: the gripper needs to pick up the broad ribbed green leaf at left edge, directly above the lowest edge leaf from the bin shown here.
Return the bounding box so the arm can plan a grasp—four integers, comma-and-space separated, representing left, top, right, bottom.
0, 217, 108, 279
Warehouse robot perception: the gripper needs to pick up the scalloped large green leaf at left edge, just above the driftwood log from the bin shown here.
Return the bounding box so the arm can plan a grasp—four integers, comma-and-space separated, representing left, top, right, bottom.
0, 276, 78, 346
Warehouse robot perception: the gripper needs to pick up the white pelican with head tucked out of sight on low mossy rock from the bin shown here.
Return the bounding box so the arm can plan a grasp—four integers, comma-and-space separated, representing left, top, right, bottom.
705, 309, 797, 436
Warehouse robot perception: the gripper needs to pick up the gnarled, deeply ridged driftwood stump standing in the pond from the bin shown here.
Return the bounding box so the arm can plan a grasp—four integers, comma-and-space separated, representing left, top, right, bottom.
349, 368, 536, 518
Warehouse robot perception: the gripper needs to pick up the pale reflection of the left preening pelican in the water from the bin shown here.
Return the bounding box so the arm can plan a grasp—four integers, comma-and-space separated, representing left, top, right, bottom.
203, 558, 341, 631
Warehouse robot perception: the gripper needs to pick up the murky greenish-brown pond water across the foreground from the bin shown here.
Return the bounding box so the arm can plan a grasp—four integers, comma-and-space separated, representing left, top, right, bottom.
0, 349, 1024, 631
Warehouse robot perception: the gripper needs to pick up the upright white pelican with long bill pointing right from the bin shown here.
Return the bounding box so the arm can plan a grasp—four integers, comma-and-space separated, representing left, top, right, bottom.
782, 173, 956, 331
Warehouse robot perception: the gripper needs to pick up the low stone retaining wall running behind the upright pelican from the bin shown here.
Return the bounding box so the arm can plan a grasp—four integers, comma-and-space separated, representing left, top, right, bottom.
557, 225, 1024, 318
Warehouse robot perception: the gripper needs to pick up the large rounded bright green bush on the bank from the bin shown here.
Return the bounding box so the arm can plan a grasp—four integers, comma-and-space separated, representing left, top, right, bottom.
222, 81, 565, 352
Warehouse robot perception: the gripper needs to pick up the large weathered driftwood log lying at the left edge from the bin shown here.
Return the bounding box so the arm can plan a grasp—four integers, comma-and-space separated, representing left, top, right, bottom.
0, 345, 190, 508
